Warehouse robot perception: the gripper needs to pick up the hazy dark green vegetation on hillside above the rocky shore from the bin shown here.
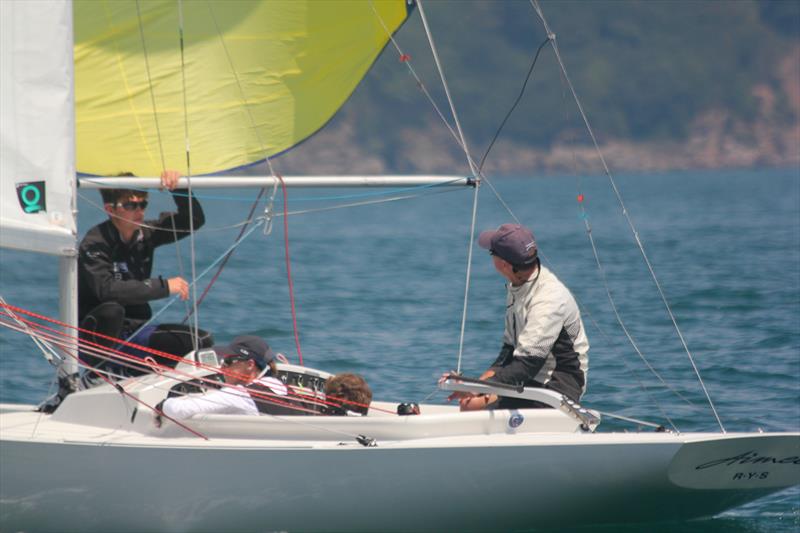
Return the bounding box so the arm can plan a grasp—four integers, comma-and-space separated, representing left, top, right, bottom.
326, 0, 800, 170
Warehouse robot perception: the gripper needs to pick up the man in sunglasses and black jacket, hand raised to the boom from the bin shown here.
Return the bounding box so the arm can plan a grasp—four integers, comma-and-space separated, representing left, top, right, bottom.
78, 170, 213, 384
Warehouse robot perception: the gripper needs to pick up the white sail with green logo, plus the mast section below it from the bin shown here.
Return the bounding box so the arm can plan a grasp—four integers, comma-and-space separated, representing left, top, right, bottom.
0, 0, 78, 375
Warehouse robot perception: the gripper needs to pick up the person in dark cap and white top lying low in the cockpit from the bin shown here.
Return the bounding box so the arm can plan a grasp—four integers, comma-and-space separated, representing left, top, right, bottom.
155, 335, 289, 420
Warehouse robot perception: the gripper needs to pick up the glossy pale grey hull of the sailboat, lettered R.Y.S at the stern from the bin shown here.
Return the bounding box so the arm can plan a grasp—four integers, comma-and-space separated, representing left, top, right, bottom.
0, 407, 800, 532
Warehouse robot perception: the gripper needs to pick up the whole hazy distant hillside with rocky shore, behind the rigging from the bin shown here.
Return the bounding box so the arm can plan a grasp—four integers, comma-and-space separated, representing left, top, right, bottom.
279, 0, 800, 174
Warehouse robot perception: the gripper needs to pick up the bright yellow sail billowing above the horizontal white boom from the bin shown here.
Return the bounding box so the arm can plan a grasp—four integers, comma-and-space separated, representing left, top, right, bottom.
74, 0, 408, 176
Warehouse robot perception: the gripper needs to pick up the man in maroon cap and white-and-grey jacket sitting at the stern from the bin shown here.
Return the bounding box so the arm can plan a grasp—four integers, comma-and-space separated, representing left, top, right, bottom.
455, 224, 589, 411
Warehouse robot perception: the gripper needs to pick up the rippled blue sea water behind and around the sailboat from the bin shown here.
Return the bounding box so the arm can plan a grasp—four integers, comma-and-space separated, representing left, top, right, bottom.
0, 169, 800, 532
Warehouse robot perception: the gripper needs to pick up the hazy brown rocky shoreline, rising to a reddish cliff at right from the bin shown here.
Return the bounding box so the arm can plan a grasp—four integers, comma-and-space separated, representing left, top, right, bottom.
274, 46, 800, 175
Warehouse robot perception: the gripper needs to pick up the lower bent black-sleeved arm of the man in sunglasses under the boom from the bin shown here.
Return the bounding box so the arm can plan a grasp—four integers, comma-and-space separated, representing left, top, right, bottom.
78, 242, 170, 305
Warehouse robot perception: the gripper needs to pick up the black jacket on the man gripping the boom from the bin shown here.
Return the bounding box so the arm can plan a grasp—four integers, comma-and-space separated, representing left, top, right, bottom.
78, 189, 205, 321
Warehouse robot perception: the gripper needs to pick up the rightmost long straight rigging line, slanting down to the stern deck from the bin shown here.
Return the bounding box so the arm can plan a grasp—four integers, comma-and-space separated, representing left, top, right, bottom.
530, 0, 727, 433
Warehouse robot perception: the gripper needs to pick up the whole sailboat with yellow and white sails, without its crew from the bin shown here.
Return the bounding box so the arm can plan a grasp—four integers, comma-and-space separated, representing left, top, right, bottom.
0, 1, 800, 531
